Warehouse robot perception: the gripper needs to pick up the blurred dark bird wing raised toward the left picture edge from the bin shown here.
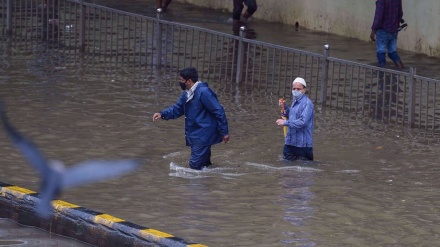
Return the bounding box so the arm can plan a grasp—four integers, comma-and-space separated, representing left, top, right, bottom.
0, 102, 49, 177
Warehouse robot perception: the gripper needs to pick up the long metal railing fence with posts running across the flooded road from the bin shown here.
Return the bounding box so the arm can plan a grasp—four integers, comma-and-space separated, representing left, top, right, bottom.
0, 0, 440, 131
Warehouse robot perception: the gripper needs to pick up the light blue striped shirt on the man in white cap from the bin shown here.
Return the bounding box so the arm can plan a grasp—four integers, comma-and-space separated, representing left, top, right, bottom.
284, 95, 315, 147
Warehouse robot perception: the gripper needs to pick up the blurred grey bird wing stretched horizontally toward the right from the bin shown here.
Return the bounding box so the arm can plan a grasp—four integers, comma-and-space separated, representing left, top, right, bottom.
61, 160, 139, 189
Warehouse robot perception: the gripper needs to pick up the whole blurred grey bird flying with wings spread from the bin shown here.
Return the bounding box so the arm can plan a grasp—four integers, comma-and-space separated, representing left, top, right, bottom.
0, 102, 139, 218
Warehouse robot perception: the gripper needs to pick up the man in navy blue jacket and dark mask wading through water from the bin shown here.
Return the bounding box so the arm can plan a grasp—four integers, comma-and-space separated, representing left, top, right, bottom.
153, 67, 229, 170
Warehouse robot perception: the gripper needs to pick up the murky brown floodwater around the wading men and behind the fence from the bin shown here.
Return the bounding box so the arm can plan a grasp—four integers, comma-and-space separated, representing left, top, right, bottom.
0, 0, 440, 247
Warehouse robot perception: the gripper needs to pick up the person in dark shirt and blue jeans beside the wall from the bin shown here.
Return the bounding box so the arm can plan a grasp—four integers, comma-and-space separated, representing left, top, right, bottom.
370, 0, 403, 68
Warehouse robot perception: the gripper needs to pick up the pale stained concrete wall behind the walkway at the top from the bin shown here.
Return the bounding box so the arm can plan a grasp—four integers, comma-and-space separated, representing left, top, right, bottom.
177, 0, 440, 57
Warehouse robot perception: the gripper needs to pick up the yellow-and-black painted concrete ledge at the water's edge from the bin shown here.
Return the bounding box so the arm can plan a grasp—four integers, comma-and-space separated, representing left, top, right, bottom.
0, 182, 206, 247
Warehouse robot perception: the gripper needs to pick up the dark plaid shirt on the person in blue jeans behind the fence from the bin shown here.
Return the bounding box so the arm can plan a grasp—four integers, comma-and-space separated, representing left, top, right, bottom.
371, 0, 403, 33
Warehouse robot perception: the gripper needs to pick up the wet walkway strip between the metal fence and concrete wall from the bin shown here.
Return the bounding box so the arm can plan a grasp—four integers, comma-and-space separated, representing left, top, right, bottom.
88, 0, 440, 79
